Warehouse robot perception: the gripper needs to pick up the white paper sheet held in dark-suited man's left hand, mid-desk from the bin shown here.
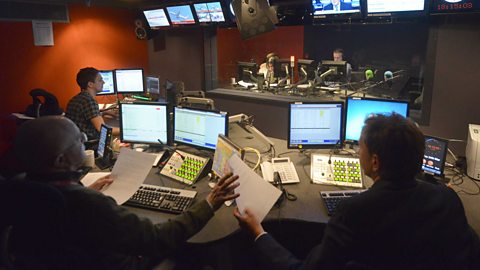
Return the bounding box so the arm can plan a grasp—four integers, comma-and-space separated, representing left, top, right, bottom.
228, 155, 281, 221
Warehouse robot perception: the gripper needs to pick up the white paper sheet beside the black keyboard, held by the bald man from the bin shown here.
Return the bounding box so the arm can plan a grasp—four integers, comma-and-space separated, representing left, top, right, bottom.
103, 147, 156, 204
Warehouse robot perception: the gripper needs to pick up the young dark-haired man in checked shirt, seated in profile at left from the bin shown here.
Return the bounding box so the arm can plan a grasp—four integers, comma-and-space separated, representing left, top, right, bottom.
65, 67, 120, 140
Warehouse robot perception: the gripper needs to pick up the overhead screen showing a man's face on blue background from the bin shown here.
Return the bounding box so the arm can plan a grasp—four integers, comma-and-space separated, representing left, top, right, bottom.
312, 0, 362, 17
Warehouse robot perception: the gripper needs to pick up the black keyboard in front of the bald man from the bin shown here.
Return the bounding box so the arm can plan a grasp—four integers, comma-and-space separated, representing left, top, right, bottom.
125, 184, 197, 214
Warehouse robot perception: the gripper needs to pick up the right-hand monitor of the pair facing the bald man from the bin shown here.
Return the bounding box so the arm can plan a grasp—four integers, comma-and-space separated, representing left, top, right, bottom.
173, 107, 228, 150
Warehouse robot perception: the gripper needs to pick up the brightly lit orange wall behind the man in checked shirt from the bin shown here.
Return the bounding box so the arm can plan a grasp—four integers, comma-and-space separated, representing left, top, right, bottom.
0, 5, 148, 113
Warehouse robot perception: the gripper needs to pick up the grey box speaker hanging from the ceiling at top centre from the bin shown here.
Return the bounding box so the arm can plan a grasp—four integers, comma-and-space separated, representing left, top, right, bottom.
232, 0, 278, 39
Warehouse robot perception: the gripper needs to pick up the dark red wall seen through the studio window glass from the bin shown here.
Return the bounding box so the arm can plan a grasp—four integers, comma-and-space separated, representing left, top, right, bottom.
217, 26, 304, 85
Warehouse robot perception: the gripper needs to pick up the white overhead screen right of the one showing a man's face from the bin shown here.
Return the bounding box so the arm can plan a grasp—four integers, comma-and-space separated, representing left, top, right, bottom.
367, 0, 425, 14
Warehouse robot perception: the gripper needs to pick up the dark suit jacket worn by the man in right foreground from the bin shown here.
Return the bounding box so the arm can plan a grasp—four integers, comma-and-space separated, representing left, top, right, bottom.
255, 180, 480, 269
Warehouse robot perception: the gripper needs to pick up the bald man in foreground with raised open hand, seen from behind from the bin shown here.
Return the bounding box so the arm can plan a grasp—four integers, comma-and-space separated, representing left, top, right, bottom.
14, 116, 239, 269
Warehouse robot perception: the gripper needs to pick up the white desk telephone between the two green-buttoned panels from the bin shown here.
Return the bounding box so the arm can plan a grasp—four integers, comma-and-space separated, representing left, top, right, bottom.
260, 157, 300, 184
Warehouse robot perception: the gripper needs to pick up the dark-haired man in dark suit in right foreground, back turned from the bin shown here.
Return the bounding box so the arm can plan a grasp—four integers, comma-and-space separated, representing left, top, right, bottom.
234, 114, 480, 270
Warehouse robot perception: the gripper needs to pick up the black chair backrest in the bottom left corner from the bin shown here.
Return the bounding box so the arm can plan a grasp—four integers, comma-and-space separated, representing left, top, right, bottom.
0, 180, 66, 269
